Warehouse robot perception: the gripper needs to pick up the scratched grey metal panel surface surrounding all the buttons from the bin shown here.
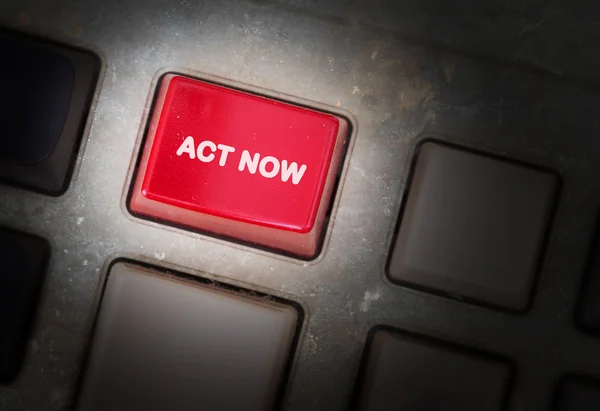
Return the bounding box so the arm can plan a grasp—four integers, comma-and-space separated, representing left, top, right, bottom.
0, 0, 600, 411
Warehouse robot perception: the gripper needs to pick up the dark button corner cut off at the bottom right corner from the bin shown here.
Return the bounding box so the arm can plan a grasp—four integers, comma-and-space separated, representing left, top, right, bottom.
554, 377, 600, 411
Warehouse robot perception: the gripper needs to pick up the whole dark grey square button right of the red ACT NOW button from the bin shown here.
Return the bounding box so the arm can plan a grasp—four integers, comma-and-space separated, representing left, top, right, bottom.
388, 141, 559, 311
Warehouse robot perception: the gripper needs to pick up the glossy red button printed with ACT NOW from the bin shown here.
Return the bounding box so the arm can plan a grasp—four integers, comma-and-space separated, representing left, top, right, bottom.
130, 75, 348, 257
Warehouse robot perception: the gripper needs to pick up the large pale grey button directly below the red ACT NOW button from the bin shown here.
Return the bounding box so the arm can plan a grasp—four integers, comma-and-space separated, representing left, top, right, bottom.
79, 263, 298, 411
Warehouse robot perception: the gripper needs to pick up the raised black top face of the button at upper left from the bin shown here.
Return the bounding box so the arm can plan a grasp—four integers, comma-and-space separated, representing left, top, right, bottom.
0, 38, 75, 163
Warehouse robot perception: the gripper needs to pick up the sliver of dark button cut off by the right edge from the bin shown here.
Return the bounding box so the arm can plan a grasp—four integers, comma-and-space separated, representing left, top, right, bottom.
578, 219, 600, 333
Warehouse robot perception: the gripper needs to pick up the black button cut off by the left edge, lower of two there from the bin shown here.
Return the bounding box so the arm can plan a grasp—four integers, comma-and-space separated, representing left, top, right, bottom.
0, 229, 50, 383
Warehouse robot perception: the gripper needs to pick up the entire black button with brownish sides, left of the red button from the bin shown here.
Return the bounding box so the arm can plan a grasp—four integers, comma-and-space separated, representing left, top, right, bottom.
0, 33, 100, 195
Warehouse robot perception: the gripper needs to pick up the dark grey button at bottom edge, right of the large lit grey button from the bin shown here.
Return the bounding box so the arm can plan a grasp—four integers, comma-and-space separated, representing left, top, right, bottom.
356, 329, 512, 411
